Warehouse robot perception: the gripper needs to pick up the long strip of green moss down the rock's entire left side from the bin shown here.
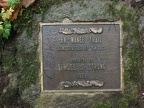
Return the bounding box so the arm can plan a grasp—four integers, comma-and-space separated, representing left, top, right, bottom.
0, 0, 71, 108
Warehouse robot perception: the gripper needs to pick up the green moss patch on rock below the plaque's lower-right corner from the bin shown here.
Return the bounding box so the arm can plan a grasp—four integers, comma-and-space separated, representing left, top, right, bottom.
93, 83, 139, 108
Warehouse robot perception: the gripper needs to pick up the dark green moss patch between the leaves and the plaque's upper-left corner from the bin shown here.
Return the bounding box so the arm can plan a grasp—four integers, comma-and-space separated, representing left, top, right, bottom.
12, 0, 67, 37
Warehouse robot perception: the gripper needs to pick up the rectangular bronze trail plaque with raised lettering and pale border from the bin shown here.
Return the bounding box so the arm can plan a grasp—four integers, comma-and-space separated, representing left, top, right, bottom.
40, 22, 123, 92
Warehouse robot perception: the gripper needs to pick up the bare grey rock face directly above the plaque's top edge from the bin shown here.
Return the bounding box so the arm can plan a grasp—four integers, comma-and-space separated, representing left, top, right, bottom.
43, 0, 112, 22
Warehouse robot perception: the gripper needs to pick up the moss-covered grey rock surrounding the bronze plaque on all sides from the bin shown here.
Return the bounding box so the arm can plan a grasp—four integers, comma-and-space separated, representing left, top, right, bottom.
0, 0, 144, 108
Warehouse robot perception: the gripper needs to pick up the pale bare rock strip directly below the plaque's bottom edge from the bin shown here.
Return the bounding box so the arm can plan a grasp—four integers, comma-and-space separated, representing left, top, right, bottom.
35, 92, 109, 108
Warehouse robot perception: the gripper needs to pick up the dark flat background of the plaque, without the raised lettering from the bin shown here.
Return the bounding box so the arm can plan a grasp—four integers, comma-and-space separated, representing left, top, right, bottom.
41, 24, 121, 91
